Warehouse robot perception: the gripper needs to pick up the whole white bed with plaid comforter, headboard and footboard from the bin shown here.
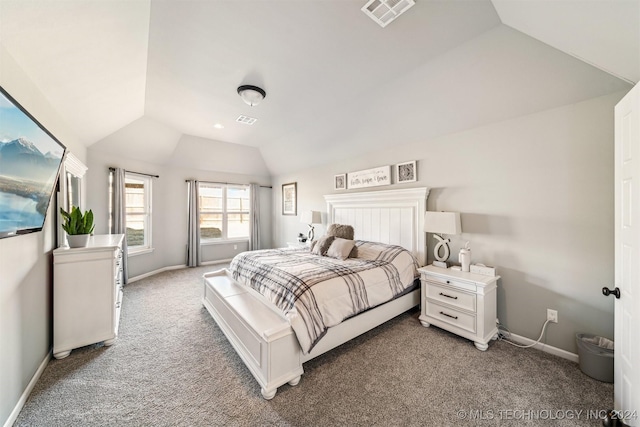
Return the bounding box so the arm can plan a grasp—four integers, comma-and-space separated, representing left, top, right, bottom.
202, 187, 429, 399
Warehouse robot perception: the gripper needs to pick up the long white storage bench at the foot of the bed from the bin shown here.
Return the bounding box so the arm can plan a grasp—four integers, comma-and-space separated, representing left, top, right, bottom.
202, 269, 304, 399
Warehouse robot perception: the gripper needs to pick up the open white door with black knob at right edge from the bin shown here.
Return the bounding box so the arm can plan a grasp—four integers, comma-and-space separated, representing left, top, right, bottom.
609, 85, 640, 426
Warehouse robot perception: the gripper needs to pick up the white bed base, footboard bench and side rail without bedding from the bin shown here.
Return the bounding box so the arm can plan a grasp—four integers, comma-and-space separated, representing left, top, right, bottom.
202, 269, 420, 400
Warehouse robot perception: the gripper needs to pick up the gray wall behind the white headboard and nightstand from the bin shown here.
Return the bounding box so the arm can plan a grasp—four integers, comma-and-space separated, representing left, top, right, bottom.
274, 93, 624, 353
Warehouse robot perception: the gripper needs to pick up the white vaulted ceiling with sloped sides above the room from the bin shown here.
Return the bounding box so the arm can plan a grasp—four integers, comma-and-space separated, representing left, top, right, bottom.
0, 0, 640, 175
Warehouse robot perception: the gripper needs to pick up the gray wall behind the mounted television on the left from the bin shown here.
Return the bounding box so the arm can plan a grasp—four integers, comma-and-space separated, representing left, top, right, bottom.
0, 45, 86, 424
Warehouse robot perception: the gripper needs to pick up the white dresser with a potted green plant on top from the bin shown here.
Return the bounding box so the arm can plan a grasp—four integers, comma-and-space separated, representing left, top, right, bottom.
53, 234, 124, 359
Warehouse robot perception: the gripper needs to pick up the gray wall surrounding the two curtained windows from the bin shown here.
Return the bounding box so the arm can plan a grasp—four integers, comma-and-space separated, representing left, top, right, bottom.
87, 148, 272, 278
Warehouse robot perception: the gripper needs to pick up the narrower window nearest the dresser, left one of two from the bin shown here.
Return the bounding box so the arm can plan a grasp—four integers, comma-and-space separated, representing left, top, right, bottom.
124, 172, 151, 254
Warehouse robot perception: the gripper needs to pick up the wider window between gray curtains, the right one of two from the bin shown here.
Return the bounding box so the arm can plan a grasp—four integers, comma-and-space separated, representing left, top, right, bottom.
198, 183, 250, 242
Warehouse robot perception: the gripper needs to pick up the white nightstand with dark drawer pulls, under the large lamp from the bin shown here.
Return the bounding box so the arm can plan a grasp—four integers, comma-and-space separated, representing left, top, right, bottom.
418, 265, 500, 351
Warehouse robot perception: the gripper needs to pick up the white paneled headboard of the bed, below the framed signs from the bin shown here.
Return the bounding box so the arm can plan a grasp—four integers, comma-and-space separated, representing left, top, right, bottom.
324, 187, 429, 265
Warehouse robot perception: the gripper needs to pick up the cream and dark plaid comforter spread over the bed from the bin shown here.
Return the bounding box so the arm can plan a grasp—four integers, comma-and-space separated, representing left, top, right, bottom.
230, 241, 418, 354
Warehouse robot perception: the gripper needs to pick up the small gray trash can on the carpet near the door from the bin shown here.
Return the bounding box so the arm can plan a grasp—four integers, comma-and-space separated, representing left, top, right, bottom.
576, 334, 613, 383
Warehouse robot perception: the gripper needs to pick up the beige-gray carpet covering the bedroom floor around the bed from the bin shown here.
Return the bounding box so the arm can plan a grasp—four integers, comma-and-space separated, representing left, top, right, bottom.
15, 267, 613, 426
